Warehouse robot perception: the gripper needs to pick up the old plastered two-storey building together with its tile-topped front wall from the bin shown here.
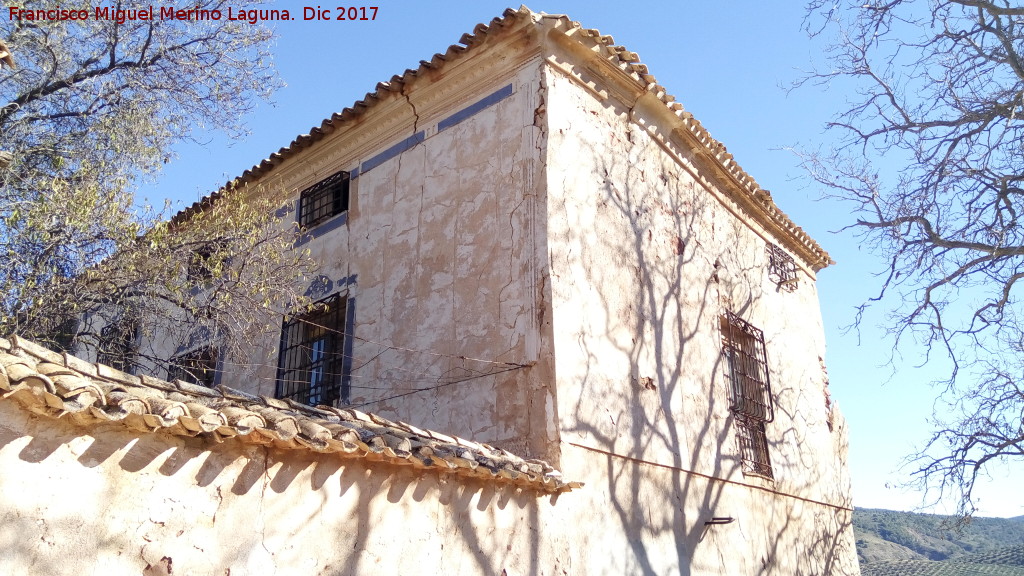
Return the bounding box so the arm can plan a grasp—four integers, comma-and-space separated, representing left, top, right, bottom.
0, 8, 859, 576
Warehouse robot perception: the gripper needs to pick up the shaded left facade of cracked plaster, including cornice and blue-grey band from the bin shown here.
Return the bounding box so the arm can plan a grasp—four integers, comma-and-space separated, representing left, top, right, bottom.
133, 27, 557, 460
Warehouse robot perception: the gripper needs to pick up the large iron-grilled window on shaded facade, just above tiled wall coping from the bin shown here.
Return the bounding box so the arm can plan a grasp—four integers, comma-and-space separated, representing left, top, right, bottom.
275, 293, 348, 406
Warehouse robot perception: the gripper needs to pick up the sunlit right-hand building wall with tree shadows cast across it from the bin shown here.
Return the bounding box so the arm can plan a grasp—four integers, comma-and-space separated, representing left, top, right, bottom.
545, 35, 858, 575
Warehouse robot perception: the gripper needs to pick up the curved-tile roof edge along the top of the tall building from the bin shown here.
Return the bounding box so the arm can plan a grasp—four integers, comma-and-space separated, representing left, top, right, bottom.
173, 6, 835, 271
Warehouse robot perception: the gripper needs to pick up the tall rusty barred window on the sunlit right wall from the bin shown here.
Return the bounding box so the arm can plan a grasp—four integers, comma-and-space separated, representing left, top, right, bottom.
721, 312, 775, 478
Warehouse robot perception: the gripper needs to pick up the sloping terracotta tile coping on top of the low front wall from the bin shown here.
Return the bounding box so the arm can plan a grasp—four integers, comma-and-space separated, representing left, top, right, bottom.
0, 336, 583, 492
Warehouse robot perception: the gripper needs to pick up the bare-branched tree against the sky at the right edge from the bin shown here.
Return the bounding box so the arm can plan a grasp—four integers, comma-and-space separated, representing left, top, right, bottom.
805, 0, 1024, 515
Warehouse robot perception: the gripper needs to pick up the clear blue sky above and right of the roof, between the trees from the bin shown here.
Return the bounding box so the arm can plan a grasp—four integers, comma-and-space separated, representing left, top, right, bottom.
142, 0, 1024, 517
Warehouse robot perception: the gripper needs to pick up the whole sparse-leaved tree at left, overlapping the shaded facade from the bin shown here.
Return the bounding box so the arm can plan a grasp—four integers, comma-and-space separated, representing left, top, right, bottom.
0, 0, 308, 377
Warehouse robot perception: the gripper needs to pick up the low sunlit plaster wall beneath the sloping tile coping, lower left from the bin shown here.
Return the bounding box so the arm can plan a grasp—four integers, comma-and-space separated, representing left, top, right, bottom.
0, 400, 581, 576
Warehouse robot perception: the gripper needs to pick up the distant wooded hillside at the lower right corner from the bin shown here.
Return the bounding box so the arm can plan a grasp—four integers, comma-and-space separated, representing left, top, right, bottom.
853, 508, 1024, 565
